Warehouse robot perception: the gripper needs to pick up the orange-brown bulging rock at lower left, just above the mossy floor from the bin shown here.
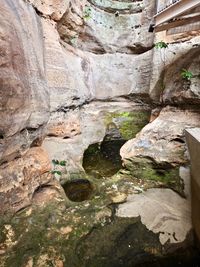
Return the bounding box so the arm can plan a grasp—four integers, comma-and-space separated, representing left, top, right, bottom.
0, 147, 51, 213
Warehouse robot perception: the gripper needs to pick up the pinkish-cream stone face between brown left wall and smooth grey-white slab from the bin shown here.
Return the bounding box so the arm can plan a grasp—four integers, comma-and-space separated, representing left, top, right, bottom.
42, 19, 92, 111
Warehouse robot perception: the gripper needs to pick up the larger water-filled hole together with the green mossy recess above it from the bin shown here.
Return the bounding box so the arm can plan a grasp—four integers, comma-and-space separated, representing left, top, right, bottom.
83, 110, 150, 179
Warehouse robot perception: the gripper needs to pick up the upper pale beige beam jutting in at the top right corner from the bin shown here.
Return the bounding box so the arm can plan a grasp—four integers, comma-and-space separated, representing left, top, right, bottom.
154, 0, 200, 28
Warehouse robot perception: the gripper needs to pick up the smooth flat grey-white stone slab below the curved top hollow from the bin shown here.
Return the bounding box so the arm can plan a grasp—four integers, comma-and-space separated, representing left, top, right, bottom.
91, 51, 152, 99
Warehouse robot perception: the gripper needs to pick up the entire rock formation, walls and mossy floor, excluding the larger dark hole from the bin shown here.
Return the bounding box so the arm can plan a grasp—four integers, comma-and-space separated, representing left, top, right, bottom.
0, 0, 200, 267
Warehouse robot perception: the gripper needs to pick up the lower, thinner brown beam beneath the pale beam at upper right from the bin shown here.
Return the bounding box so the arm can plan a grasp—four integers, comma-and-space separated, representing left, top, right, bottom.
155, 15, 200, 32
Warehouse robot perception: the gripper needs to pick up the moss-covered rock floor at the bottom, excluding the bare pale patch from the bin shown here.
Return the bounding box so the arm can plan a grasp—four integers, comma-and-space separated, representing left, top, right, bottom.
0, 168, 198, 267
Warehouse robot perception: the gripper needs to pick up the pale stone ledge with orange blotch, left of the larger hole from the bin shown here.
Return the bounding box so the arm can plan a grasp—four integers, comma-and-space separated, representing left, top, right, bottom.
42, 101, 149, 182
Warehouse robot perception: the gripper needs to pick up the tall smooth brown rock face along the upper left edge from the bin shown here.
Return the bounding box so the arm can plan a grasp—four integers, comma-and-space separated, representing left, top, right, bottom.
0, 0, 49, 162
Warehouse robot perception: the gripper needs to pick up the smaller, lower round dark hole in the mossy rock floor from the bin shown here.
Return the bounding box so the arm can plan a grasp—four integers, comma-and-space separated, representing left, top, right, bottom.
63, 179, 94, 202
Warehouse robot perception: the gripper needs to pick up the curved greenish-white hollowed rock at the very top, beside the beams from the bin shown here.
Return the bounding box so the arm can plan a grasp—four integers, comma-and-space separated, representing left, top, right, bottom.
58, 0, 155, 54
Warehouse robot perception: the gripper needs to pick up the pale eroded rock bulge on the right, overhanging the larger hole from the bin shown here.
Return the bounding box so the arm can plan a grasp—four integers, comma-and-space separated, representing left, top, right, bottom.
121, 107, 200, 165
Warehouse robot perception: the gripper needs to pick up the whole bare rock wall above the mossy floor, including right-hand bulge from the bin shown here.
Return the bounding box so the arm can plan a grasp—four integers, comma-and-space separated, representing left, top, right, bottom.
0, 0, 200, 252
